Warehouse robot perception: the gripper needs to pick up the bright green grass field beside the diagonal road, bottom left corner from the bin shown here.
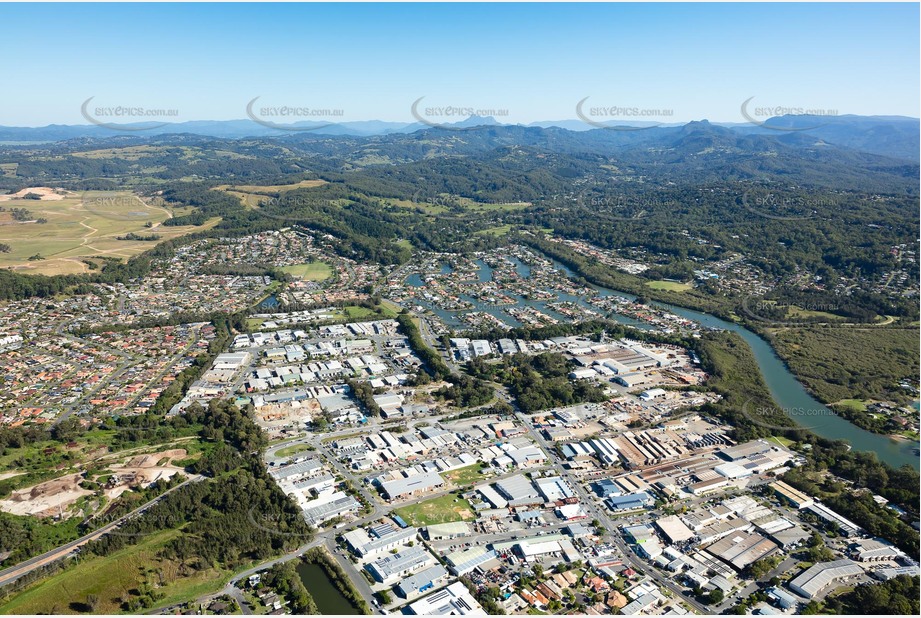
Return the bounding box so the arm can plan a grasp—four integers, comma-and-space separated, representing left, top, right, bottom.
0, 530, 230, 614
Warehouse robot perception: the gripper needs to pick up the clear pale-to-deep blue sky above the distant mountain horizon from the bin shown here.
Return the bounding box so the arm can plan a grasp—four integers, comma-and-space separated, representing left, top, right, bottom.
0, 3, 921, 126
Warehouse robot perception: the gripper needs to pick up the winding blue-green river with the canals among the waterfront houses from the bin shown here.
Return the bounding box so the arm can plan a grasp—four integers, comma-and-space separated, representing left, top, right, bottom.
407, 259, 919, 470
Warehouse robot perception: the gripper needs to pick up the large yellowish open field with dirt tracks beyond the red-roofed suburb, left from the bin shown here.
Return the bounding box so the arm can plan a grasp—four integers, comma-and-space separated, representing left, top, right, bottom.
0, 191, 220, 275
